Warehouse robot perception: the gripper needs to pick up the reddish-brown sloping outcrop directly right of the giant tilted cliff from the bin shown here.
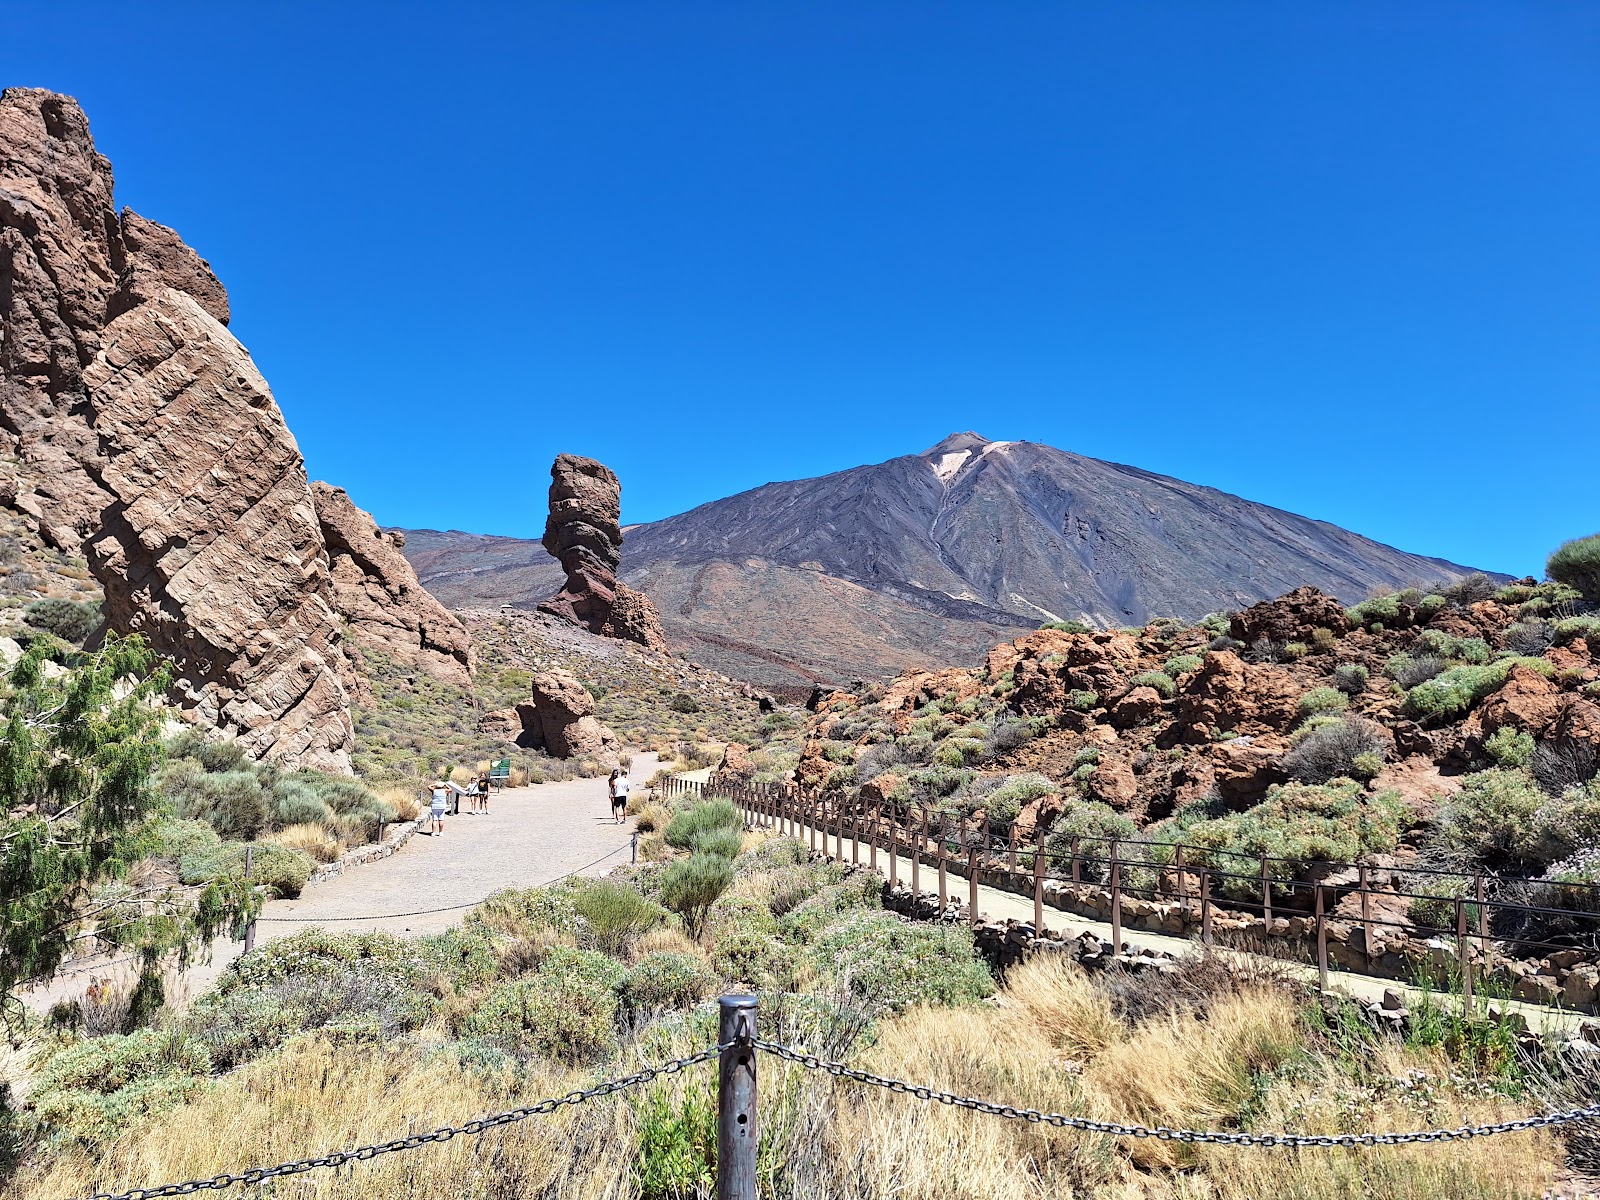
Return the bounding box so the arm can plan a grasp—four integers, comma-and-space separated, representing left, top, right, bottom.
310, 482, 472, 688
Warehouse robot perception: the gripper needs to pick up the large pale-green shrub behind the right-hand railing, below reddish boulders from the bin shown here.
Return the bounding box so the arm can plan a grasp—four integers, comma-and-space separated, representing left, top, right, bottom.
1184, 782, 1413, 899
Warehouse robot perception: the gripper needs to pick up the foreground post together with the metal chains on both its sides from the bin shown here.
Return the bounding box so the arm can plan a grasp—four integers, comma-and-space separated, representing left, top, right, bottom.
78, 995, 1600, 1200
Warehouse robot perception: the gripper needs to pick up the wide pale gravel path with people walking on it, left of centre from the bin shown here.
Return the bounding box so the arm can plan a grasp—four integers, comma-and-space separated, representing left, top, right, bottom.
19, 754, 658, 1013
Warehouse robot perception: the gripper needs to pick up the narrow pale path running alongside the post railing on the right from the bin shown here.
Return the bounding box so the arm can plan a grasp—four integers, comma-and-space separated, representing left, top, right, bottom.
768, 822, 1595, 1034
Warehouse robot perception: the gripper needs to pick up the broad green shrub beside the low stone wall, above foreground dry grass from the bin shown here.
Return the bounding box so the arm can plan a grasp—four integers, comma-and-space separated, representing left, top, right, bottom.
811, 912, 994, 1013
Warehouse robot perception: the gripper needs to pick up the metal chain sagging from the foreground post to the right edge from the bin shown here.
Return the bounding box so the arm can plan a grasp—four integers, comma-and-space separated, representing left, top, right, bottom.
754, 1038, 1600, 1147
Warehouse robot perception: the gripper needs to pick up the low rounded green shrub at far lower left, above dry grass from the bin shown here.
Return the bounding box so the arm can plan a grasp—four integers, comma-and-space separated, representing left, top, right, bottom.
30, 1029, 211, 1144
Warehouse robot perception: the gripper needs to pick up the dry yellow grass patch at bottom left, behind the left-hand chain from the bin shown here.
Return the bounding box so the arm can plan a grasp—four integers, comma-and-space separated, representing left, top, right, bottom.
11, 1038, 632, 1200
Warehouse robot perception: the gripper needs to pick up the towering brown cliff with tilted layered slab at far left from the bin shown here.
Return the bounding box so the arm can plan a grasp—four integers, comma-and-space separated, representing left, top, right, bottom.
0, 88, 354, 771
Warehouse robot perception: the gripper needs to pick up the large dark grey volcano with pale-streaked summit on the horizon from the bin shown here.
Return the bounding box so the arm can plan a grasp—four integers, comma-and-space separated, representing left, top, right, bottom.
396, 434, 1470, 686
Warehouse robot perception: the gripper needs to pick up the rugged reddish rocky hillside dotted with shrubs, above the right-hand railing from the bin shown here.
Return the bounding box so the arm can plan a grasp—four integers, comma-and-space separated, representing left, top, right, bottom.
780, 563, 1600, 928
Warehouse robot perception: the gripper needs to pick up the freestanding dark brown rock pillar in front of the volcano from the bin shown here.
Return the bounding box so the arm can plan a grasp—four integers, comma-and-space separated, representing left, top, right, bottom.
539, 454, 667, 651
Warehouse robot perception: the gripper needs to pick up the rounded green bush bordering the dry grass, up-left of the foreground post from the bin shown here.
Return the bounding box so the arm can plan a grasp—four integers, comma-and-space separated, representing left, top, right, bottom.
461, 946, 627, 1062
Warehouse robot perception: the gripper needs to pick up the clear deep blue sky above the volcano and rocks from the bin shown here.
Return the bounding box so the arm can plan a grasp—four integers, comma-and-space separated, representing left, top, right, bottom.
0, 0, 1600, 573
